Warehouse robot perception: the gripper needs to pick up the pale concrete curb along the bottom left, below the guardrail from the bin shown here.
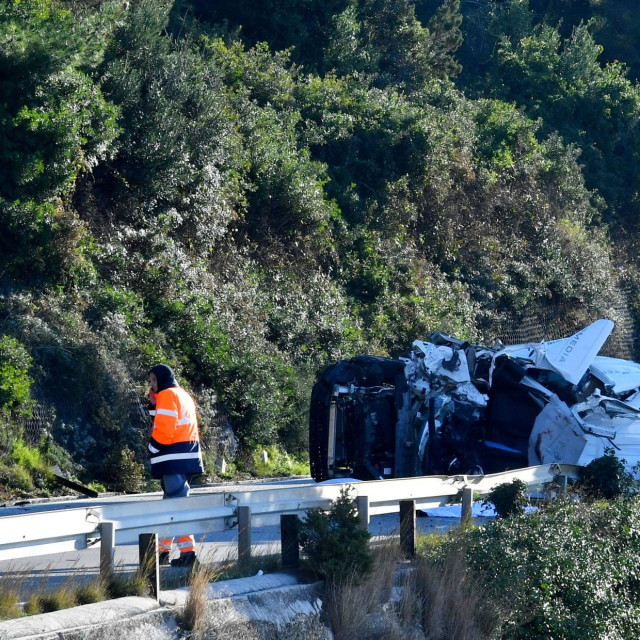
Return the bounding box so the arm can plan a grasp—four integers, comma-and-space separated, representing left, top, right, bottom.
0, 573, 332, 640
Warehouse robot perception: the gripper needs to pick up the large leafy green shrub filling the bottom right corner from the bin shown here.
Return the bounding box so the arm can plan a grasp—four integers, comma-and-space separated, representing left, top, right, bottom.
465, 498, 640, 640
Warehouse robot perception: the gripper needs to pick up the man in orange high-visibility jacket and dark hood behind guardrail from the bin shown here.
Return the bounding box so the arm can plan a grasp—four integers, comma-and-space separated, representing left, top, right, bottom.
149, 364, 204, 566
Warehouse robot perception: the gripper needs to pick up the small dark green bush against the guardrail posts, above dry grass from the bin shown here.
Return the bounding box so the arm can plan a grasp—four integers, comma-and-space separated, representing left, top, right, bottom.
300, 489, 373, 584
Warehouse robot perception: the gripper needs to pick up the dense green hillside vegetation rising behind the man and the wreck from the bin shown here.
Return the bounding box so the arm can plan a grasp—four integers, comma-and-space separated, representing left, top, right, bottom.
0, 0, 640, 488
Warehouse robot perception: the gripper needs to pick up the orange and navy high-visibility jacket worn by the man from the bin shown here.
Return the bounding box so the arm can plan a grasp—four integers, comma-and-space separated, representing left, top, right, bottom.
149, 387, 204, 478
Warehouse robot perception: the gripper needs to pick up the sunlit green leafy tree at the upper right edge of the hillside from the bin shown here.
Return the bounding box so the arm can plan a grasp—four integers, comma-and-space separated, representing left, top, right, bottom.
498, 24, 640, 221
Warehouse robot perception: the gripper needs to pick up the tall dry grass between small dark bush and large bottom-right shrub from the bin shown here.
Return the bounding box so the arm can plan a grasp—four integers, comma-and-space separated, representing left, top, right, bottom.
325, 540, 500, 640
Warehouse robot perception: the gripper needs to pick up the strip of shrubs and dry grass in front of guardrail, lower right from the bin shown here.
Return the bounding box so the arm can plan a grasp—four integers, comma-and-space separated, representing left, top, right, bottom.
312, 484, 640, 640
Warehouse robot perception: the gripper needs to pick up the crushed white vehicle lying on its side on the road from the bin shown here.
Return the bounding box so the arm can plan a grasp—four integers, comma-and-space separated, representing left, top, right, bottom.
309, 319, 640, 482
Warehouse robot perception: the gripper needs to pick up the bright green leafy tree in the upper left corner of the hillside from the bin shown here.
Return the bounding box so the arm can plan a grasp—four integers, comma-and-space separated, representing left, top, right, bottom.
0, 0, 116, 286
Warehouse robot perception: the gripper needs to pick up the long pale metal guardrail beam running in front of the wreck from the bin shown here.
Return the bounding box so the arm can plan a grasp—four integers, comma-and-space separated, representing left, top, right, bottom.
0, 464, 579, 560
